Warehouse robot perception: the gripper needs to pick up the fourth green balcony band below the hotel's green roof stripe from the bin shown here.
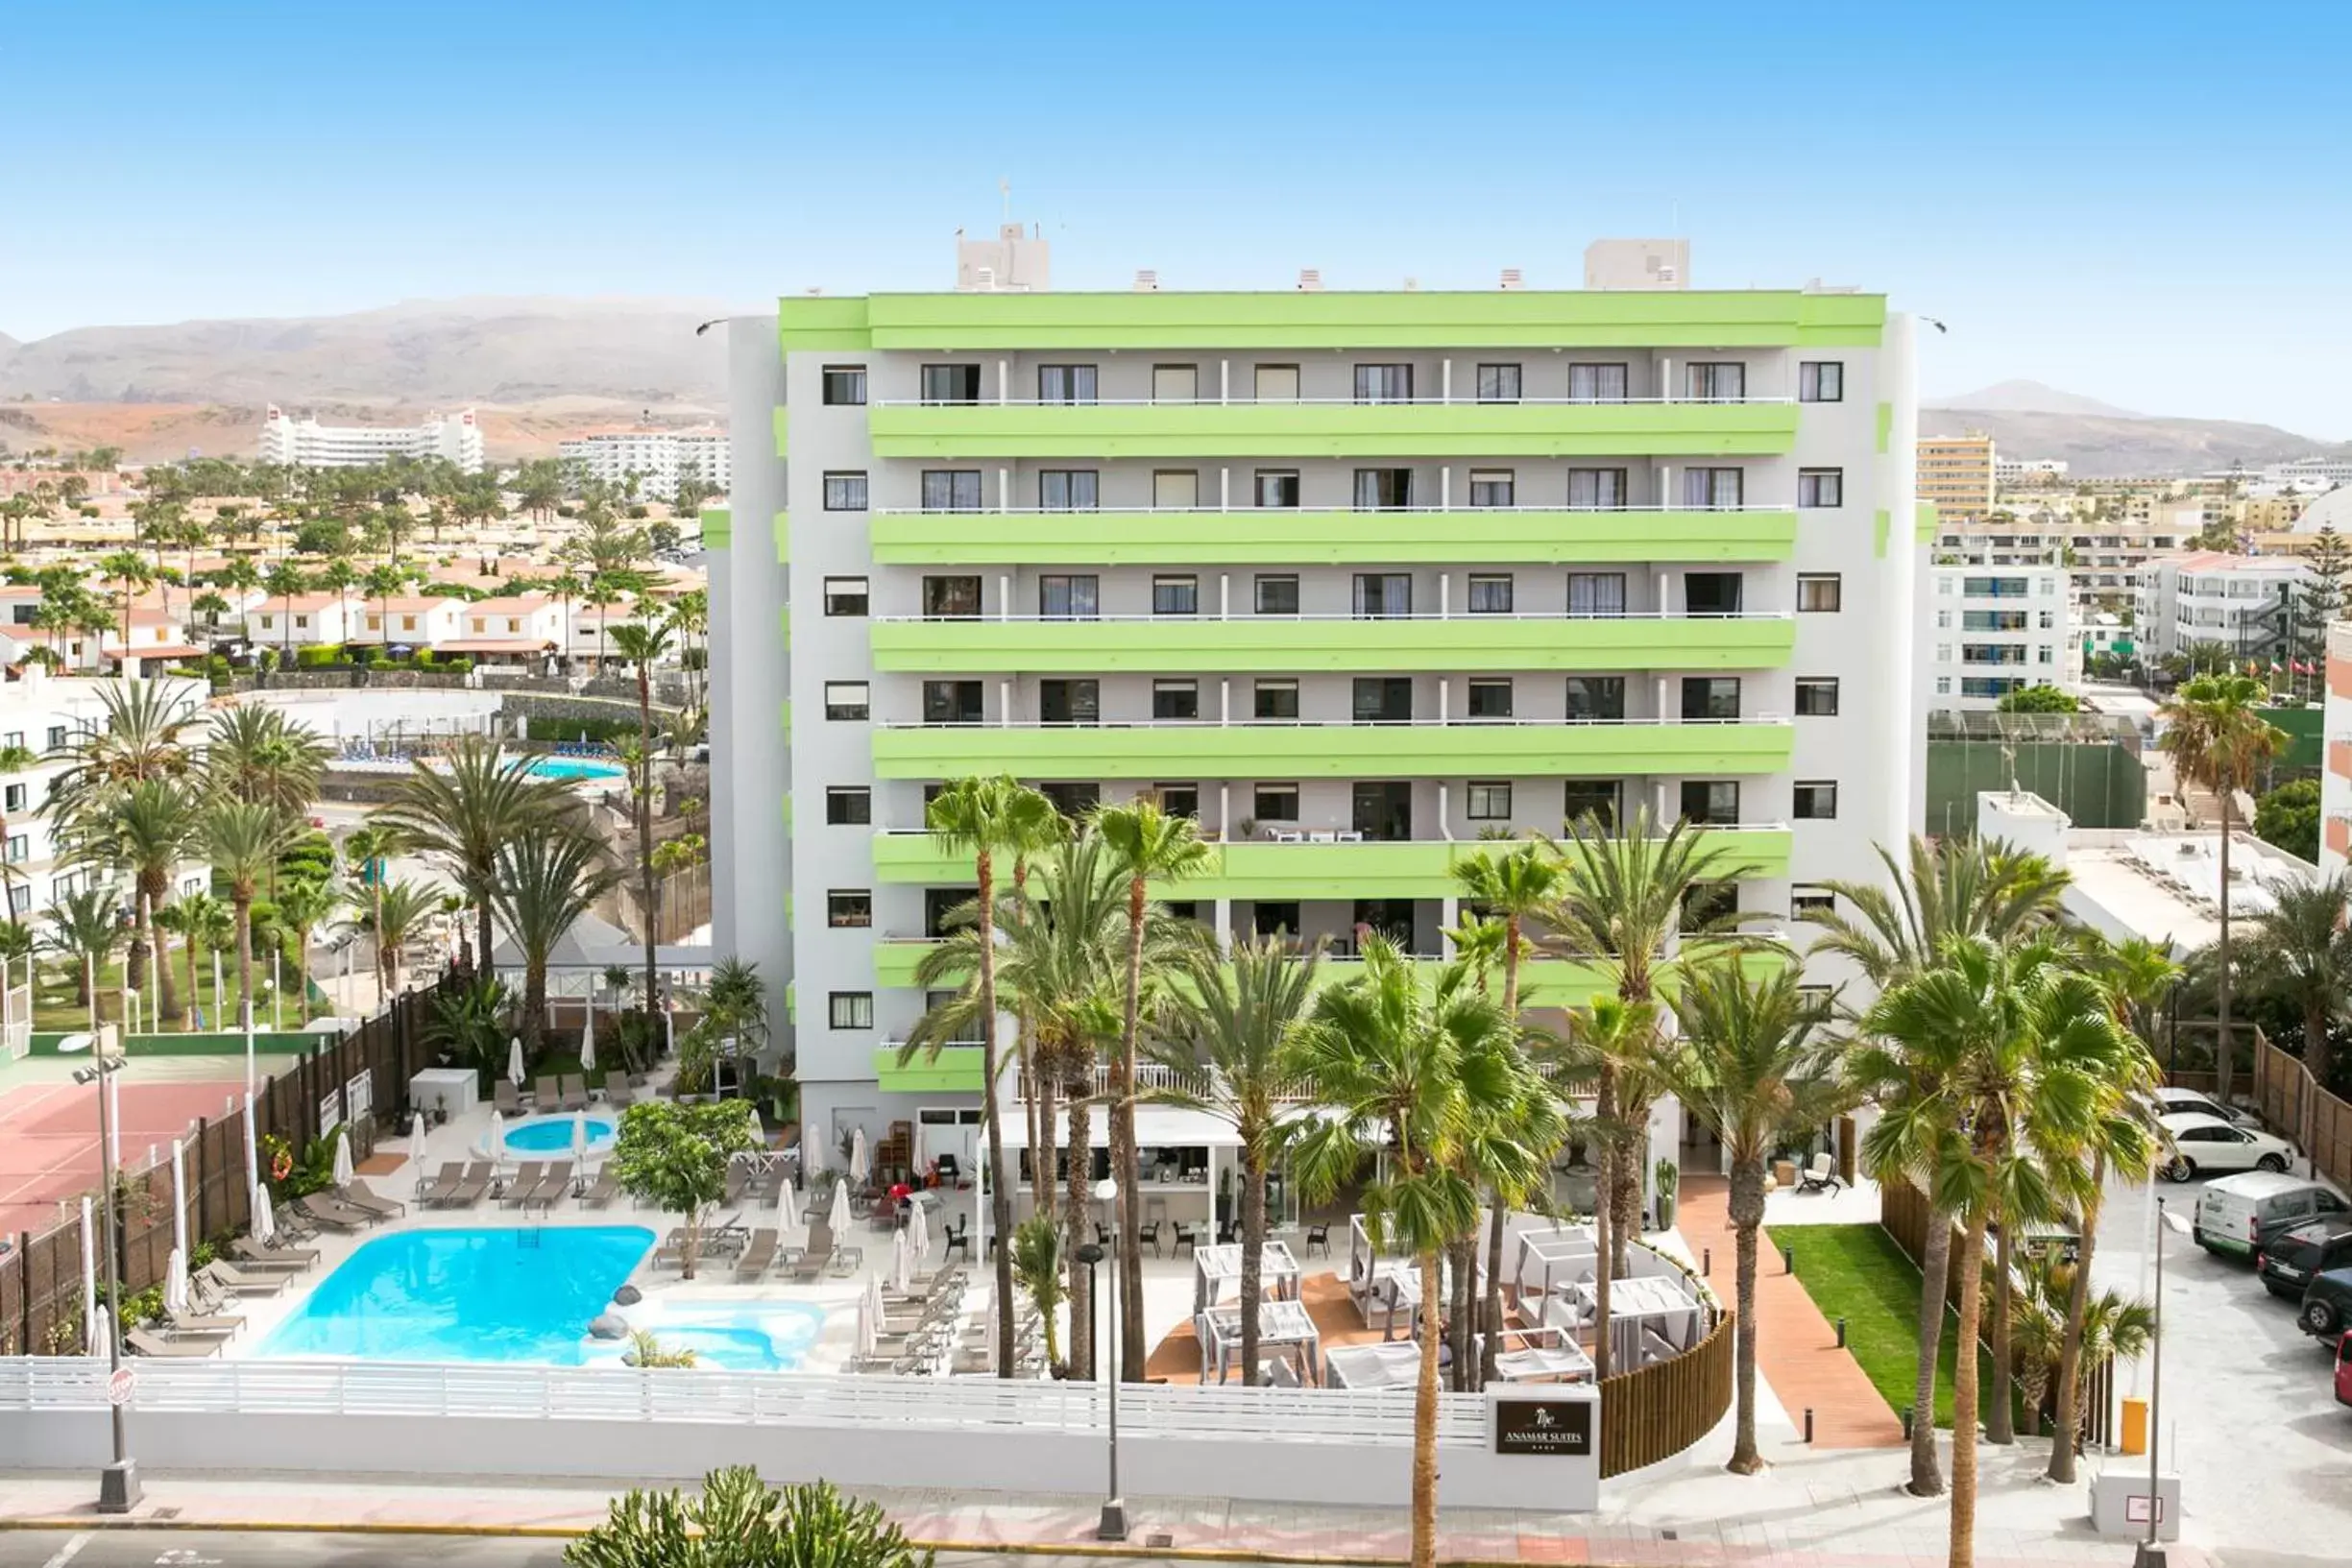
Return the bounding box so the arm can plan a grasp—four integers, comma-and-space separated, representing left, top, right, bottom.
873, 714, 1795, 778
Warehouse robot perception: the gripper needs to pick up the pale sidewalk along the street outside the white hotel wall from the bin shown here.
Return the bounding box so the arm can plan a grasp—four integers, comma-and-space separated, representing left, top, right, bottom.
0, 1432, 2209, 1568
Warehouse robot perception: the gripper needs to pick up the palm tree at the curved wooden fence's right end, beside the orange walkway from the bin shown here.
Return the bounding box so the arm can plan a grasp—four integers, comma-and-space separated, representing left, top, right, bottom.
1665, 961, 1844, 1477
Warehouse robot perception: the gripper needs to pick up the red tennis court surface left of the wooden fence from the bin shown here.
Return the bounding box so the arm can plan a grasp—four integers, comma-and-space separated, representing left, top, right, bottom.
0, 1076, 245, 1234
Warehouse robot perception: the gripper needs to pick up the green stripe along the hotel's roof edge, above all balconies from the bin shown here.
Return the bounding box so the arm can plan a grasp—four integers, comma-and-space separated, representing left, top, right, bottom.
776, 289, 1886, 352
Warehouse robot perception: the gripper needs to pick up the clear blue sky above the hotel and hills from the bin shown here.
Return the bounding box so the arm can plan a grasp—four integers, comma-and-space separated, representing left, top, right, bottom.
0, 0, 2352, 437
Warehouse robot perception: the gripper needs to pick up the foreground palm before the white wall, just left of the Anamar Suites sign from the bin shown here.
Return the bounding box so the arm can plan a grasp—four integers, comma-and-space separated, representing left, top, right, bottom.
1284, 931, 1540, 1568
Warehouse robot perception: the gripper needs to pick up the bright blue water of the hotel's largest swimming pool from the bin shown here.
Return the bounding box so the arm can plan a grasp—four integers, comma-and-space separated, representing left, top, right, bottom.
258, 1225, 654, 1365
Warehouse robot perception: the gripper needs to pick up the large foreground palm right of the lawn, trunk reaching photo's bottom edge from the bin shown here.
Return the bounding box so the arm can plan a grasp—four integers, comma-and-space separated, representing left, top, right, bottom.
1858, 938, 2138, 1568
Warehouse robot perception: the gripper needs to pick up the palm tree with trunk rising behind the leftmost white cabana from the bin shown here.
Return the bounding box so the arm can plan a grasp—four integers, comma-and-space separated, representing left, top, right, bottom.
1143, 935, 1321, 1383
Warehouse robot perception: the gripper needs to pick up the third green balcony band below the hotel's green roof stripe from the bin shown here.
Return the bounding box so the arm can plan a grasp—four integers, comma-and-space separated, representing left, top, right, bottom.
870, 614, 1797, 675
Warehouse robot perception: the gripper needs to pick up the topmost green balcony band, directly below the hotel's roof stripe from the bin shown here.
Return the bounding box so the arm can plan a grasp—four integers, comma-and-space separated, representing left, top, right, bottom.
868, 398, 1797, 458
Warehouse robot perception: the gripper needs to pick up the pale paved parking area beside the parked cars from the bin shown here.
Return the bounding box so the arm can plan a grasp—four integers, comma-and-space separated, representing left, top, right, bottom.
2091, 1182, 2352, 1568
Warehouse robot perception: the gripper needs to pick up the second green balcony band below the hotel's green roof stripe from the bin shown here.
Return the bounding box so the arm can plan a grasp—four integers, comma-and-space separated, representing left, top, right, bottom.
870, 505, 1797, 567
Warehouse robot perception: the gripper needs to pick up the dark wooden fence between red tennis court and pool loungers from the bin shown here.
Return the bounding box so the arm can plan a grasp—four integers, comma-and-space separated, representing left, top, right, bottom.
0, 990, 449, 1357
